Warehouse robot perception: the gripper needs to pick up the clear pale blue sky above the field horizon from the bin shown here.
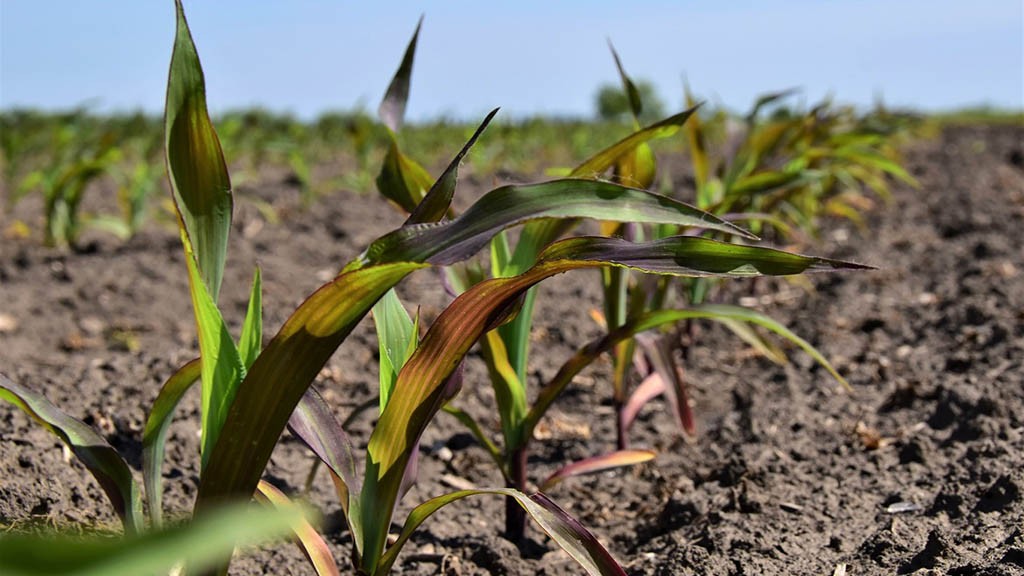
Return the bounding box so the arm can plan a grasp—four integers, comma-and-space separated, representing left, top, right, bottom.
0, 0, 1024, 120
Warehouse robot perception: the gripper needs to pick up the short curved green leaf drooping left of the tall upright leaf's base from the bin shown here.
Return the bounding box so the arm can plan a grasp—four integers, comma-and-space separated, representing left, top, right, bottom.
142, 358, 202, 528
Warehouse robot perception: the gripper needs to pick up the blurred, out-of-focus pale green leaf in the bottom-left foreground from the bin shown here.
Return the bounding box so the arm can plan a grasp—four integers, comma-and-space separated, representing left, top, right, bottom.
0, 504, 304, 576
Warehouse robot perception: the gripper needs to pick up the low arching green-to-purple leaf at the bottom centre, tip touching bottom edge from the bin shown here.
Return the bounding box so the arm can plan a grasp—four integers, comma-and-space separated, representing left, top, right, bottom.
374, 488, 626, 576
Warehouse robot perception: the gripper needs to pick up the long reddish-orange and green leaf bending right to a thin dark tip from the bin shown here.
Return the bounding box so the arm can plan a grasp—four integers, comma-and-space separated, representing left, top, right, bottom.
362, 237, 864, 559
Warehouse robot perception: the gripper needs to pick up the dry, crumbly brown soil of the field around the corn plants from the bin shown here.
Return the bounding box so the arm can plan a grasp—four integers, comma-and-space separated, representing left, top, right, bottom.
0, 126, 1024, 575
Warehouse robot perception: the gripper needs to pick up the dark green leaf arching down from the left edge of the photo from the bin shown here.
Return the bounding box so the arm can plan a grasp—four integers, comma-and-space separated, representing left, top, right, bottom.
0, 374, 143, 532
